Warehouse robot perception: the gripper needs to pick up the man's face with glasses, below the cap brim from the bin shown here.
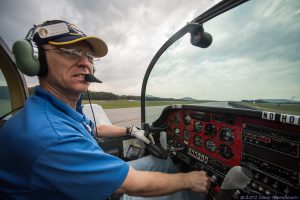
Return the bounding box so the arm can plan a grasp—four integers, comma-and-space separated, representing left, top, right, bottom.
40, 42, 93, 97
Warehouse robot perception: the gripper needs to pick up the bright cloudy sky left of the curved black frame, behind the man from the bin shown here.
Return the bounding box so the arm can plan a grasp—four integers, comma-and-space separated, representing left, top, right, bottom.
0, 0, 218, 95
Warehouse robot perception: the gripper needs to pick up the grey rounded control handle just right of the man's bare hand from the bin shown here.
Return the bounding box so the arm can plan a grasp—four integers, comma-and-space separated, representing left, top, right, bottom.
216, 166, 253, 200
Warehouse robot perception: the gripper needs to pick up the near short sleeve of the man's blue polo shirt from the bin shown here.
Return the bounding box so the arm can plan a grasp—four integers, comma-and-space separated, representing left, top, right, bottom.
31, 136, 129, 199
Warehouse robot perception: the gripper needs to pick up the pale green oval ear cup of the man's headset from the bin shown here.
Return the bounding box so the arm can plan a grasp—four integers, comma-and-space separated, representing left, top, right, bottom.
12, 40, 40, 76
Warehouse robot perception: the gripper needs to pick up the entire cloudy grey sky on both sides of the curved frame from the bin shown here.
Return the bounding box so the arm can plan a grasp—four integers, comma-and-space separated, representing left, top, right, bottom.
0, 0, 300, 101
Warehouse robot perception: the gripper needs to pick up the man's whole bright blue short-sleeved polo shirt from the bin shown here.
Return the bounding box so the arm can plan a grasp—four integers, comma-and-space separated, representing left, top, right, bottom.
0, 87, 129, 199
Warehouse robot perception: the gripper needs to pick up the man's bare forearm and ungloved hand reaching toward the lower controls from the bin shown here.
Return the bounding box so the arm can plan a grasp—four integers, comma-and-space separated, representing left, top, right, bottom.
116, 167, 210, 197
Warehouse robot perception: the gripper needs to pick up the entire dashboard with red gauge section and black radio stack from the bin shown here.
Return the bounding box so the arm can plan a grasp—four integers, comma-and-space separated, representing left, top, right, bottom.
153, 106, 300, 199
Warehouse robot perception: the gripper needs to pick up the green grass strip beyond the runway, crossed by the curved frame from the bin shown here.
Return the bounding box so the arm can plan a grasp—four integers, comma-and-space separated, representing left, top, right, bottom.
83, 100, 199, 109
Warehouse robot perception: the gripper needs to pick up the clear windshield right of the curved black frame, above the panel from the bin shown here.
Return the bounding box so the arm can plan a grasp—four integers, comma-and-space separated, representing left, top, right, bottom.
145, 0, 300, 124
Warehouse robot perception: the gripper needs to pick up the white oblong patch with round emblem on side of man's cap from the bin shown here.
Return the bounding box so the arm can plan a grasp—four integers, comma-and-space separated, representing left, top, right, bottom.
36, 23, 69, 39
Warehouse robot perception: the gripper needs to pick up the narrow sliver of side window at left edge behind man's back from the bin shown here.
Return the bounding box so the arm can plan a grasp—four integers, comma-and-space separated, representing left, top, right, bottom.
0, 69, 12, 117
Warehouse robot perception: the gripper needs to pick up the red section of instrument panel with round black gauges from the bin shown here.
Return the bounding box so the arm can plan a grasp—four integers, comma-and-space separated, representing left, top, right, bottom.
166, 110, 242, 166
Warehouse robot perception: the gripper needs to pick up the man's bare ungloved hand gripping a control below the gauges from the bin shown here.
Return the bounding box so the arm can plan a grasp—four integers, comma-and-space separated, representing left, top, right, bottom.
186, 171, 211, 193
